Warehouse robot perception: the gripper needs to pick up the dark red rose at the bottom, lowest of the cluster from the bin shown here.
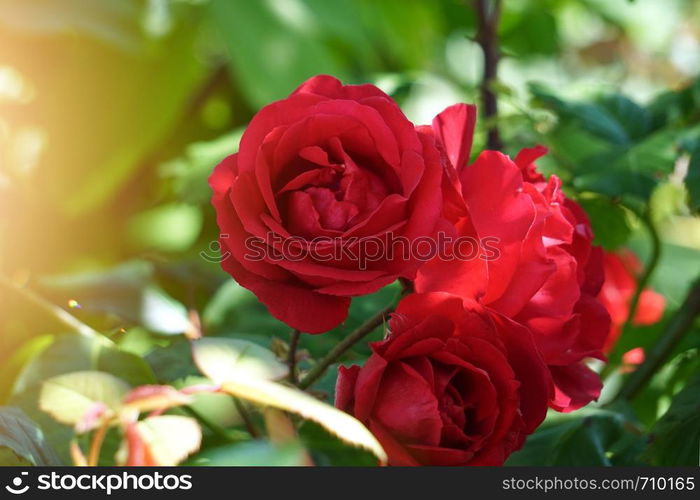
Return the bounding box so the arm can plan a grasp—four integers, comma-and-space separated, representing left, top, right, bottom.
336, 293, 552, 465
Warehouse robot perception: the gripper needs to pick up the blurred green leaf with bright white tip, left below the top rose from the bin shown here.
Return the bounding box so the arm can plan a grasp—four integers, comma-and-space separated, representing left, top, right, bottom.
42, 261, 190, 335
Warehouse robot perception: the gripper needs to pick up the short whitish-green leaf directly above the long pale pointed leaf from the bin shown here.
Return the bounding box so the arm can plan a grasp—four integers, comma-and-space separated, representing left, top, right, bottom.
192, 337, 287, 383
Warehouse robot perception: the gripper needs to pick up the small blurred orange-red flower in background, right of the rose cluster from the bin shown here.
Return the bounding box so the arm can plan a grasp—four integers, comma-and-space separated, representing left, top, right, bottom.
598, 250, 666, 352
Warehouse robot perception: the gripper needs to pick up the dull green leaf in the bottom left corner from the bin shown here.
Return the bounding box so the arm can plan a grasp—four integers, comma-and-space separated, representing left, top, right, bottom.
0, 406, 61, 466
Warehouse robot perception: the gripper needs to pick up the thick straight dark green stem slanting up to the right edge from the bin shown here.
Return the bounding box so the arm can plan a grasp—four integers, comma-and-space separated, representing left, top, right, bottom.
613, 278, 700, 401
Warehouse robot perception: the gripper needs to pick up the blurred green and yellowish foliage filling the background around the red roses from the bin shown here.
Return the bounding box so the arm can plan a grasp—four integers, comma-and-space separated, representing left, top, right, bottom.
0, 0, 700, 466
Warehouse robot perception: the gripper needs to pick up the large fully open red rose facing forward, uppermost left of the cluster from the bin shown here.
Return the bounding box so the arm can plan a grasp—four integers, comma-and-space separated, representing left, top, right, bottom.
210, 76, 442, 333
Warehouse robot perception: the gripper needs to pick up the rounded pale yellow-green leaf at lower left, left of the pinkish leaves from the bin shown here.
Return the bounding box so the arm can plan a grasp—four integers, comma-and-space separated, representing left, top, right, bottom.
39, 371, 130, 426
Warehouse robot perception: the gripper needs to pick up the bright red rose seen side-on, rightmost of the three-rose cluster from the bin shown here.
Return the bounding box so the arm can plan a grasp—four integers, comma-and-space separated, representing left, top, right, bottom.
415, 104, 610, 411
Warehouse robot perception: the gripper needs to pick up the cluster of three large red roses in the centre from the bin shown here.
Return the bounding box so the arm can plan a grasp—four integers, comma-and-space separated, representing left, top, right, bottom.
210, 76, 610, 465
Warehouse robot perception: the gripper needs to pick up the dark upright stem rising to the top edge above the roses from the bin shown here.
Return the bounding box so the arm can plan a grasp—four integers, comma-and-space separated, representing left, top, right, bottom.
474, 0, 503, 150
